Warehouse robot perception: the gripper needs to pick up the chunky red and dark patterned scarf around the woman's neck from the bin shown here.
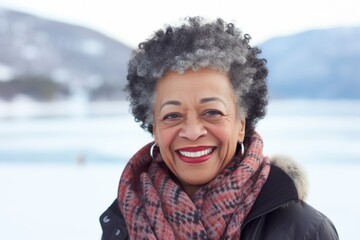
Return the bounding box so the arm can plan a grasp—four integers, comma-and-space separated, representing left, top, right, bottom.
118, 133, 270, 239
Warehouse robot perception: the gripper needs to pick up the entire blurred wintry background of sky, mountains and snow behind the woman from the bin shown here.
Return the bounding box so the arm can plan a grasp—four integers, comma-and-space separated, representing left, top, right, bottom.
0, 0, 360, 240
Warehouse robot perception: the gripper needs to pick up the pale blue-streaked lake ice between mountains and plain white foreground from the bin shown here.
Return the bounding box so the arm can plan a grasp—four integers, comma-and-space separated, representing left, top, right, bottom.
0, 101, 360, 164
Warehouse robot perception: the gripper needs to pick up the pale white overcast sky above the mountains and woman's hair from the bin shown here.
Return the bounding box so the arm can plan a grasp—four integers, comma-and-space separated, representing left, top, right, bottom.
0, 0, 360, 46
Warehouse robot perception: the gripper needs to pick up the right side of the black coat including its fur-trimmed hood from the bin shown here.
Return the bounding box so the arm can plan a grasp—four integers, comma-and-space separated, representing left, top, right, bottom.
242, 157, 338, 240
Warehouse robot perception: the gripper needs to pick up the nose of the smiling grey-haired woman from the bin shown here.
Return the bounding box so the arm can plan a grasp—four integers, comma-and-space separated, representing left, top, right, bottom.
179, 118, 207, 141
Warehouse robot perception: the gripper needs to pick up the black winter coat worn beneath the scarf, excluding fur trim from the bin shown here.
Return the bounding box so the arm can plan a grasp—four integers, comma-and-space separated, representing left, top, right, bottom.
100, 165, 339, 240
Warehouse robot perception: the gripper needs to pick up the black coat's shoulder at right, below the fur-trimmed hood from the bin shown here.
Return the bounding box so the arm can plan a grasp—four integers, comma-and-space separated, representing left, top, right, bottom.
241, 200, 339, 240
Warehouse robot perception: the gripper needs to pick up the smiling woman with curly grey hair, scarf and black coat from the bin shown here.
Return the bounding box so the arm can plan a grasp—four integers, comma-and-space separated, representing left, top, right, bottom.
100, 18, 338, 240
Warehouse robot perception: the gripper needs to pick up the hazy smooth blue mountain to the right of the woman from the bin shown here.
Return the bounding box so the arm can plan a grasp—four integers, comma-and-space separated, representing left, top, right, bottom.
260, 27, 360, 99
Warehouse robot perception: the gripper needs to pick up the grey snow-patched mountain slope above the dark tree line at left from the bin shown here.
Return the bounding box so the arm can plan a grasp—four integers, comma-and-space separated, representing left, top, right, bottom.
0, 8, 131, 100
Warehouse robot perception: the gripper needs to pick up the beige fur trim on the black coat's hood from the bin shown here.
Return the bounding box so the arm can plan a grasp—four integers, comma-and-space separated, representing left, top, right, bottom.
270, 155, 309, 201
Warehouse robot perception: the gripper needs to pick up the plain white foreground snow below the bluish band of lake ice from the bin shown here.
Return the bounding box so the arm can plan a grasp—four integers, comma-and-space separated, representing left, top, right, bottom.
0, 164, 360, 240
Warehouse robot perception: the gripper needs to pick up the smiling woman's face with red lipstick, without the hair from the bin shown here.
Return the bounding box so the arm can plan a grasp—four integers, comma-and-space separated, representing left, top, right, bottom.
153, 69, 245, 195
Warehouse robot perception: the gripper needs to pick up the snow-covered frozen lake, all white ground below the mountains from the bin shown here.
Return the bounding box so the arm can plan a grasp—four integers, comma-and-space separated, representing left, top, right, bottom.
0, 101, 360, 240
